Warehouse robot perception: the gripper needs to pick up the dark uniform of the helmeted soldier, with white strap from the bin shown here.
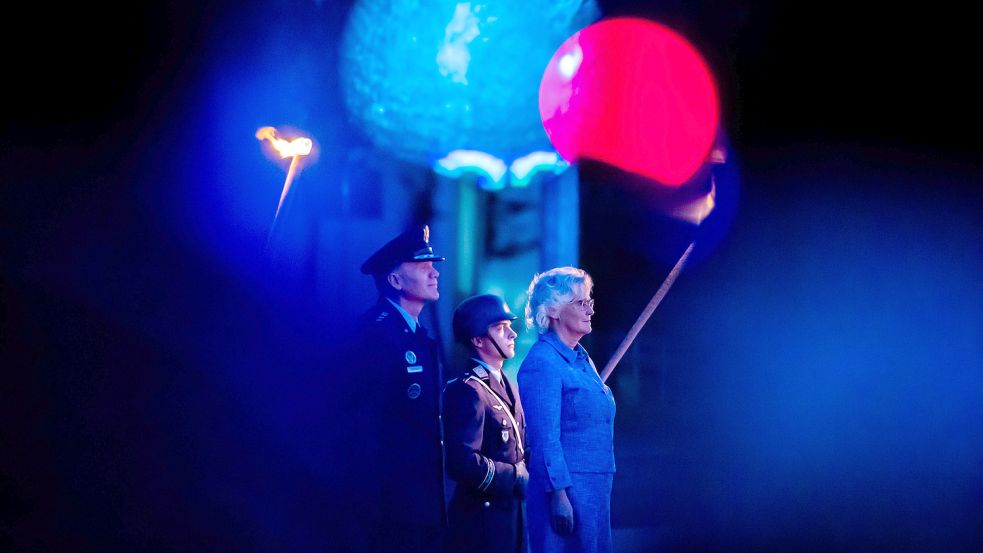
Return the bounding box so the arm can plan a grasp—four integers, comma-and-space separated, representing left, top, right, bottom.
444, 363, 526, 552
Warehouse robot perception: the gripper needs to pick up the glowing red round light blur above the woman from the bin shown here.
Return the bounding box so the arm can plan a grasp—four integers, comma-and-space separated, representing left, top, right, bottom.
539, 18, 719, 186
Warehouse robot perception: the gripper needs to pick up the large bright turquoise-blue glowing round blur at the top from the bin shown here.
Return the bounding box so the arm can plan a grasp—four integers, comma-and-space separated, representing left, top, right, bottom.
340, 0, 600, 166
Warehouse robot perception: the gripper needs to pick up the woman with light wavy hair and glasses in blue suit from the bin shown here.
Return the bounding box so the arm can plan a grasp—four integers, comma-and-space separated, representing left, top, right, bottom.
518, 267, 615, 553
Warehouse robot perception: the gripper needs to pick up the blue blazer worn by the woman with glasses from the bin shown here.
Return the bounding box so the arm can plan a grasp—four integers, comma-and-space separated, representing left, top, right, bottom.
518, 332, 615, 492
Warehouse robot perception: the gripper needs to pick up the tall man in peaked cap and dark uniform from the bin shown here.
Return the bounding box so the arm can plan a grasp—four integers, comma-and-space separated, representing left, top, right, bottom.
346, 226, 446, 553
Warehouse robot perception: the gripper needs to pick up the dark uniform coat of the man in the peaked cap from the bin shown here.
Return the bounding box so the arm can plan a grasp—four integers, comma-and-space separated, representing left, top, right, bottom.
336, 298, 446, 551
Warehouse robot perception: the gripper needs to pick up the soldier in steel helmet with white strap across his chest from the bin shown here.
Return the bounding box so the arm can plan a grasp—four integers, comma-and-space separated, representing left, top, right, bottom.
444, 294, 529, 553
